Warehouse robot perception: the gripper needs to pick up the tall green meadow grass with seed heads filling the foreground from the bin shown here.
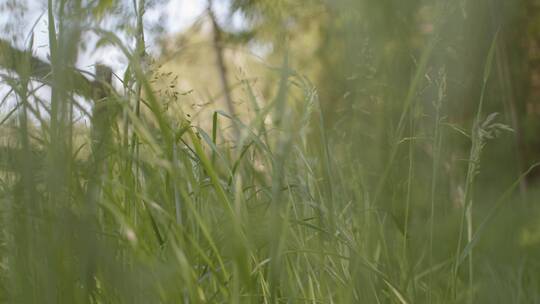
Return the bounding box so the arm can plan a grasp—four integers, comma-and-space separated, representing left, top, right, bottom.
0, 1, 540, 304
